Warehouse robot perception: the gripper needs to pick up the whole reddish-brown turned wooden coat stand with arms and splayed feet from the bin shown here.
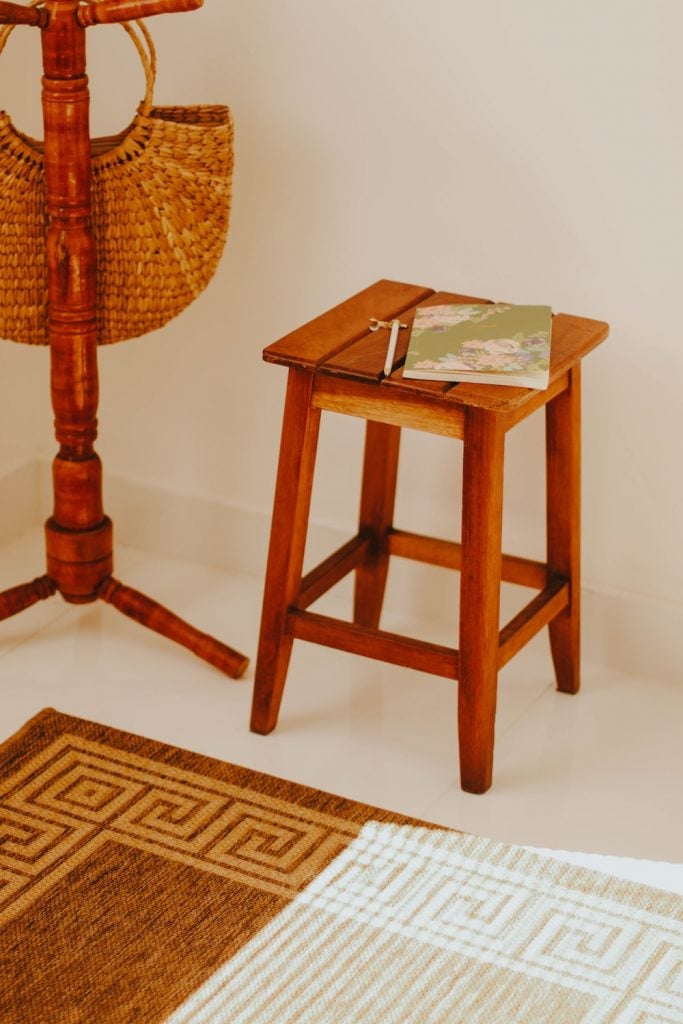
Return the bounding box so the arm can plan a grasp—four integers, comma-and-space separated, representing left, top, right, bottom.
0, 0, 248, 678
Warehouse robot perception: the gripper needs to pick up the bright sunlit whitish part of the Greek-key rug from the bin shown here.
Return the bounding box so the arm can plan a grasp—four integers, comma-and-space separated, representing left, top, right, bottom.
168, 822, 683, 1024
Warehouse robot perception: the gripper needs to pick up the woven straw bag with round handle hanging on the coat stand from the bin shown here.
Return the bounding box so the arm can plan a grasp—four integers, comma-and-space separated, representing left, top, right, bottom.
0, 23, 232, 345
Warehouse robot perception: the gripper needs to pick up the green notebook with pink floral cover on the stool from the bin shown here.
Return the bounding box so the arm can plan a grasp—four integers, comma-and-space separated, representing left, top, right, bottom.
403, 303, 552, 390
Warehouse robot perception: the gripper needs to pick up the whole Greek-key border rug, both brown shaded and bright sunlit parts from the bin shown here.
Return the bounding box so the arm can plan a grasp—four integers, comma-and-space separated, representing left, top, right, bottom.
0, 711, 683, 1024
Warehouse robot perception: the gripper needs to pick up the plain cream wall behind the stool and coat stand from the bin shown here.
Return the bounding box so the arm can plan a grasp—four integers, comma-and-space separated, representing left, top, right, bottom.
0, 0, 683, 675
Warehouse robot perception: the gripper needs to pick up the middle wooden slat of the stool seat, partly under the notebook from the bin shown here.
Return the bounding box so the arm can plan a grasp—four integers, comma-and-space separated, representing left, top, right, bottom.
318, 292, 489, 391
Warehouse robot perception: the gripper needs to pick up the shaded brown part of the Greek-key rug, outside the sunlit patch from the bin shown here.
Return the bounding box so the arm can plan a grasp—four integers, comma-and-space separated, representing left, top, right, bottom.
0, 710, 428, 1024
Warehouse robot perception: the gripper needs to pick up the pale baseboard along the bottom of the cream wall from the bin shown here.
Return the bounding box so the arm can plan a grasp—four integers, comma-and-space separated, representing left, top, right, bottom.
0, 460, 683, 682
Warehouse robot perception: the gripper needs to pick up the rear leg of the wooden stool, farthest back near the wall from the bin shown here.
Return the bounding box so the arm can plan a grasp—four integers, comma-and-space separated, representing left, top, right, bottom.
353, 420, 400, 629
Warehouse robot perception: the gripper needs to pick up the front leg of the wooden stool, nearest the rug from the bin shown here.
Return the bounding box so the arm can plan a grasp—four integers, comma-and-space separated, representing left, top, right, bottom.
458, 408, 505, 793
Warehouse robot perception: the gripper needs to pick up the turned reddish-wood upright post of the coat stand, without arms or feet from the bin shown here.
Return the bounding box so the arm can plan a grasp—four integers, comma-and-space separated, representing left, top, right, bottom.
42, 0, 113, 603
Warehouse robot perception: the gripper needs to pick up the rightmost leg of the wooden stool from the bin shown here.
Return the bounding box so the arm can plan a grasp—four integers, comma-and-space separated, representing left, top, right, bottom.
546, 364, 581, 693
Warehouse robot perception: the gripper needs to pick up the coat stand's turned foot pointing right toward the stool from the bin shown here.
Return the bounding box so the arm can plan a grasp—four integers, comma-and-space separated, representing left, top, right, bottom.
97, 577, 249, 679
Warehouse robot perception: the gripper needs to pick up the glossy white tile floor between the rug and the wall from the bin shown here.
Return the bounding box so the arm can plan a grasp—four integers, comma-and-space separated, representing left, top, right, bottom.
0, 530, 683, 876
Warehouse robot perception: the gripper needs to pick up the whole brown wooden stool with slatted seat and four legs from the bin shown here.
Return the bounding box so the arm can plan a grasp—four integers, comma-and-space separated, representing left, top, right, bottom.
251, 281, 608, 793
